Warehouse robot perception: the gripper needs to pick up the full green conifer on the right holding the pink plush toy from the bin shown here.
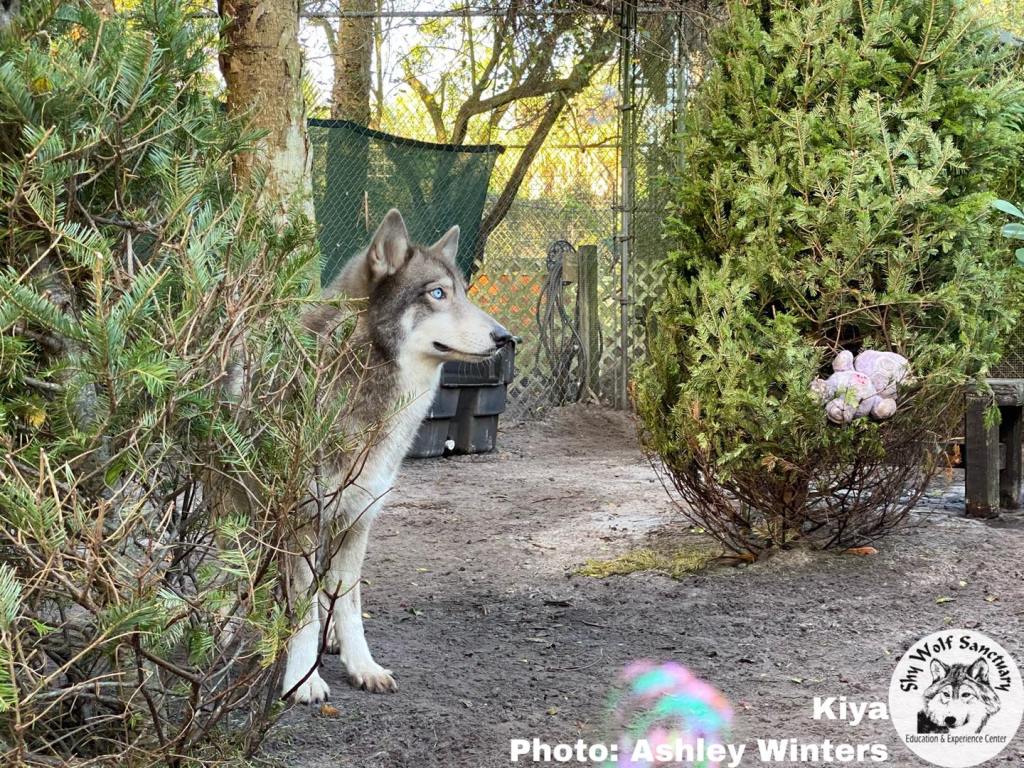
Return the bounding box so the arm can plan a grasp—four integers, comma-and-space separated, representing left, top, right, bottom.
636, 0, 1024, 552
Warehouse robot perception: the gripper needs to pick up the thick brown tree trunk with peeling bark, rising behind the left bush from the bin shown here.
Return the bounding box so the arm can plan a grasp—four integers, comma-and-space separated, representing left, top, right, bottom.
218, 0, 312, 210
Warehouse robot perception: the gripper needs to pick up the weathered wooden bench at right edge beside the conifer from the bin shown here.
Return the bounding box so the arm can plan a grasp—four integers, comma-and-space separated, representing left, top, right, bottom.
964, 379, 1024, 517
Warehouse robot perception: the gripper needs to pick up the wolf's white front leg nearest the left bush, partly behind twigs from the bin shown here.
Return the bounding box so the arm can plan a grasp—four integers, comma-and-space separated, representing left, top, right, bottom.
282, 537, 331, 703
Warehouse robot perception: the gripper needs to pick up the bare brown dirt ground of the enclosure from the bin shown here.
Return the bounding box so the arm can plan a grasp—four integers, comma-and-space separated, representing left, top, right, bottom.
265, 408, 1024, 768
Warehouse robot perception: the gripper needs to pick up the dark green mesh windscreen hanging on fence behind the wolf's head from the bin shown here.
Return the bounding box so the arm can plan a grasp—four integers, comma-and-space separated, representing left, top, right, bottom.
309, 120, 503, 285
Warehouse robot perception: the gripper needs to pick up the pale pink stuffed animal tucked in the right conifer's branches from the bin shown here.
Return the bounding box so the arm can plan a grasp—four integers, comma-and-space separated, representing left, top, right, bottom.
811, 349, 909, 424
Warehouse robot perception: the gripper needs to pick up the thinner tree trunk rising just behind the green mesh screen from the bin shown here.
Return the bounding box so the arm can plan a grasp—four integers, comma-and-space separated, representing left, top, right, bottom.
331, 0, 377, 125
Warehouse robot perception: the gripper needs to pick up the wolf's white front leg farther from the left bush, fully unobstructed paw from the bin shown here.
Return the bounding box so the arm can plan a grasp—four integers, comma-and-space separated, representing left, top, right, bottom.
321, 519, 398, 693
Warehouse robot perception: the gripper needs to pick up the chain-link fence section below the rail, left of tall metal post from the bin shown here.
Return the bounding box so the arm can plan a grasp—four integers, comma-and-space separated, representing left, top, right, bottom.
471, 143, 618, 417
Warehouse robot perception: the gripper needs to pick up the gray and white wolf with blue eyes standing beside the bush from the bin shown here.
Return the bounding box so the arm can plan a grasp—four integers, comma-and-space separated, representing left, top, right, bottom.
283, 209, 512, 702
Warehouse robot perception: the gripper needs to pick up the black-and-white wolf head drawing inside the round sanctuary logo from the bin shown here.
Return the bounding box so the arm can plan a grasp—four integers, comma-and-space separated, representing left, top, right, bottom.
918, 656, 999, 734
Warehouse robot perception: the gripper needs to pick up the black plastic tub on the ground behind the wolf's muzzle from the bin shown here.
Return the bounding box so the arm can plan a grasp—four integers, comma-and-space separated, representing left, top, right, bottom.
409, 344, 515, 459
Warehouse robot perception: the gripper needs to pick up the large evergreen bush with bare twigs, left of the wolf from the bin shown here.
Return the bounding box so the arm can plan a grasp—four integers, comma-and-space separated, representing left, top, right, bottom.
0, 0, 347, 765
